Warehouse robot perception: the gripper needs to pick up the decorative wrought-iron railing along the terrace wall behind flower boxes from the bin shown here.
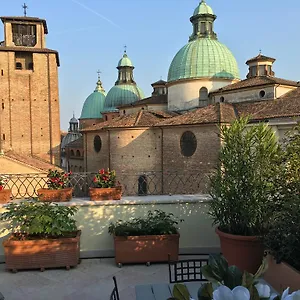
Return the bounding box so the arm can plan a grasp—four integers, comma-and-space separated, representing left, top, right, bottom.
1, 171, 206, 199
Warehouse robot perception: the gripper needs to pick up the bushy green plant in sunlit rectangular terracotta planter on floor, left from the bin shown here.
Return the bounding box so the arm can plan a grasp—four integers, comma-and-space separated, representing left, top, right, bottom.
0, 201, 81, 272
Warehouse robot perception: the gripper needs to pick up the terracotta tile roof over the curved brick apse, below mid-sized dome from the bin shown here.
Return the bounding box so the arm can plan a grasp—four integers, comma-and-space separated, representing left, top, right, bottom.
81, 110, 173, 132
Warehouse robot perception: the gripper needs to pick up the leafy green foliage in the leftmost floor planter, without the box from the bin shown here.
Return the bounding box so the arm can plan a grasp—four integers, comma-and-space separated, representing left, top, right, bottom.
0, 201, 77, 239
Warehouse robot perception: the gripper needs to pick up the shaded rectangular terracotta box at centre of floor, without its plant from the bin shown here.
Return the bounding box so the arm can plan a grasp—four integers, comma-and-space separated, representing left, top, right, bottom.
114, 234, 179, 265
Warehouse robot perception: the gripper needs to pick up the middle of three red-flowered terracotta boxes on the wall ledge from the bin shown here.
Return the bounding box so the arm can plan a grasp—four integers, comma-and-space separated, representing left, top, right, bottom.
37, 169, 73, 202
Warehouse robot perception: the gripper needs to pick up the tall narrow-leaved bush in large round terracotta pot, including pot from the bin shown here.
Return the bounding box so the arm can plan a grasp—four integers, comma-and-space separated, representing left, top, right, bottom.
209, 118, 279, 273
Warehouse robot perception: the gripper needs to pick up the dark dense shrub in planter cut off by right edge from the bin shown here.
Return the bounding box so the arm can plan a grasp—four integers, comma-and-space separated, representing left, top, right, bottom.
264, 125, 300, 291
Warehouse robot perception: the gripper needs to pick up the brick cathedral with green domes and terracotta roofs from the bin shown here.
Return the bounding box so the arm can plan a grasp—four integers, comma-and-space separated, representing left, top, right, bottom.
67, 0, 300, 194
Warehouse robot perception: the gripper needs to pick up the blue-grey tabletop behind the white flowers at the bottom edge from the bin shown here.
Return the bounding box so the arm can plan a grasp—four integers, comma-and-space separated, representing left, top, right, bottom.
135, 279, 277, 300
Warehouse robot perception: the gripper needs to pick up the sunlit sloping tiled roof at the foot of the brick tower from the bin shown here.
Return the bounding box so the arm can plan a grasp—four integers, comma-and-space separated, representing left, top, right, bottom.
4, 151, 61, 172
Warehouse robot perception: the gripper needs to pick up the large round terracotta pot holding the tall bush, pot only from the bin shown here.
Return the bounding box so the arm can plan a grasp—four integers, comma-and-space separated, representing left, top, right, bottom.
216, 228, 264, 274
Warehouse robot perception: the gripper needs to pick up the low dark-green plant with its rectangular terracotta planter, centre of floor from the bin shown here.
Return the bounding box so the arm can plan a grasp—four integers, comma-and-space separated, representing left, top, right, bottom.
108, 210, 183, 266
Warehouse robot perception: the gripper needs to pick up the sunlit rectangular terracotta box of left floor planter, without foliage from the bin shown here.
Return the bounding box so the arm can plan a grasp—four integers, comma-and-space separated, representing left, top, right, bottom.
3, 230, 81, 272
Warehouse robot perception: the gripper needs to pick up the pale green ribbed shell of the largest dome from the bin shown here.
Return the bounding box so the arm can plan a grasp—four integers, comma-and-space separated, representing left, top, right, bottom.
168, 39, 240, 82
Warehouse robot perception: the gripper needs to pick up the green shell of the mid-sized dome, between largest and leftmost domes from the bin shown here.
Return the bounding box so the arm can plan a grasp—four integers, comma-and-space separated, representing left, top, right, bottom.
104, 84, 144, 111
